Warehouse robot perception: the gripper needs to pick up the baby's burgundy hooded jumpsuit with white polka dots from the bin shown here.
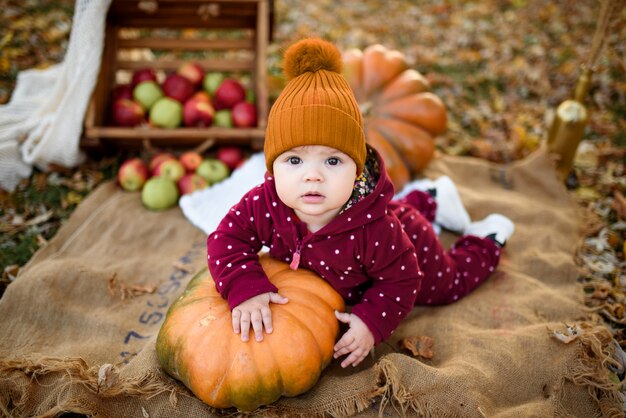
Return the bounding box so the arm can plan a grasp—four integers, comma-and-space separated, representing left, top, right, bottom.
207, 150, 500, 344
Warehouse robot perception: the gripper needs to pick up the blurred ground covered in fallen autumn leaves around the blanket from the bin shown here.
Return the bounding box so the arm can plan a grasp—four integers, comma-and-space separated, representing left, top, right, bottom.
0, 0, 626, 388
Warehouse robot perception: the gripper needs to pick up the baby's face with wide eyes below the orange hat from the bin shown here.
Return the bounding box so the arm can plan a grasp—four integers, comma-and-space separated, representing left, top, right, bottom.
273, 145, 356, 229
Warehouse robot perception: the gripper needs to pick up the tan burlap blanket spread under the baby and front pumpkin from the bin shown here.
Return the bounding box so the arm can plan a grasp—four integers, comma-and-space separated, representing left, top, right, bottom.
0, 152, 620, 417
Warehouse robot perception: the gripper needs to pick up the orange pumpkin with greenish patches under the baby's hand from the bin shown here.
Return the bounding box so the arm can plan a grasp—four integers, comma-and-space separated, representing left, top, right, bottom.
156, 256, 345, 411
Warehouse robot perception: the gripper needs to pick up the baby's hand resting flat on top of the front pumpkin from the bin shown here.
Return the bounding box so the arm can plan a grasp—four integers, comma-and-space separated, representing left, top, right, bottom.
231, 292, 287, 341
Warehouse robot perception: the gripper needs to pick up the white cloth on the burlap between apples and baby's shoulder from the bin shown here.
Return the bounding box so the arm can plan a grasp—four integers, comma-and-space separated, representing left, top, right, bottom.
179, 152, 441, 235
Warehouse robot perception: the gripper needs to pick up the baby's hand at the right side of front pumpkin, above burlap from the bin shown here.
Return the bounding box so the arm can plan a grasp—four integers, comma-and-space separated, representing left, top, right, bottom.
333, 311, 374, 367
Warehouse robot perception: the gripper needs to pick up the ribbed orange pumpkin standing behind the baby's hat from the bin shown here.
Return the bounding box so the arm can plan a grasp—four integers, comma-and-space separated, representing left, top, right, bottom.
343, 45, 447, 190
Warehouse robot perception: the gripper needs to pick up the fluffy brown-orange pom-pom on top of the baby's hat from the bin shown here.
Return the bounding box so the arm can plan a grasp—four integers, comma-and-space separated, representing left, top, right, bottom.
283, 38, 343, 80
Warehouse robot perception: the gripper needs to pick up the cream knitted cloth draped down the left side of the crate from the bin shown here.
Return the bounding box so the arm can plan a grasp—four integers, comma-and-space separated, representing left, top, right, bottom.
0, 0, 111, 191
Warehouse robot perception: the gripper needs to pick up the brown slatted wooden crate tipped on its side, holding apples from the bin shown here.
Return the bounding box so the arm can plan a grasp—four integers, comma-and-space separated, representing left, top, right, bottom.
81, 0, 273, 149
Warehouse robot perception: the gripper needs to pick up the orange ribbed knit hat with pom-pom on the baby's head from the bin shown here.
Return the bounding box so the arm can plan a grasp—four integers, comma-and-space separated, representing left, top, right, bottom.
264, 38, 367, 174
